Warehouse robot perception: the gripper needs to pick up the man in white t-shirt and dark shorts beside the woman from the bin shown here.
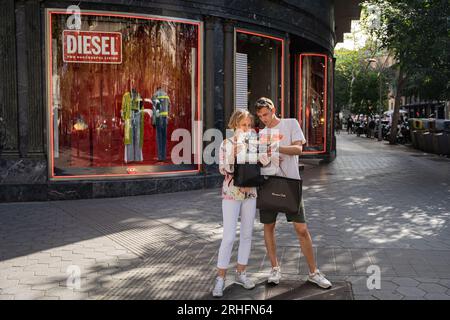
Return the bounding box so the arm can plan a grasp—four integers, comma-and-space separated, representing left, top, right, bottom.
255, 98, 331, 288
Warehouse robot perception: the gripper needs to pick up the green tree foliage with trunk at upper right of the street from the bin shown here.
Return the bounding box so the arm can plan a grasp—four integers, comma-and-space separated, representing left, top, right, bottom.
365, 0, 450, 143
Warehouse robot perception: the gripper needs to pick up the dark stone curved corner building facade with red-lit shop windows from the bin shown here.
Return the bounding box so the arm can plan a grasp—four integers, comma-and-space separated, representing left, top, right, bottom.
0, 0, 359, 201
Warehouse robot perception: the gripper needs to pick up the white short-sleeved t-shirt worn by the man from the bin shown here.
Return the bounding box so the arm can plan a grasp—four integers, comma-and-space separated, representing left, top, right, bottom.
260, 119, 306, 179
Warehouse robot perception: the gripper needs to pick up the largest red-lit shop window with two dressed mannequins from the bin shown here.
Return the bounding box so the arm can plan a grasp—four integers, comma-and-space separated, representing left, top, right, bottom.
47, 10, 201, 178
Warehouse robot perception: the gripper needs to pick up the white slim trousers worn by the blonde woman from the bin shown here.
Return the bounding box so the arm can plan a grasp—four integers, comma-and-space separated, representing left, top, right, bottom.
217, 198, 256, 269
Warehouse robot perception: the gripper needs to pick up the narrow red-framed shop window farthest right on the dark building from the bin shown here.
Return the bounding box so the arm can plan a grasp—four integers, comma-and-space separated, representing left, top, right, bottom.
298, 54, 328, 153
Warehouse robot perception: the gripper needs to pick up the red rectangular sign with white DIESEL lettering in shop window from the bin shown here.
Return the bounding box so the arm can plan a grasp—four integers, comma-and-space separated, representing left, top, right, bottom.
63, 30, 122, 64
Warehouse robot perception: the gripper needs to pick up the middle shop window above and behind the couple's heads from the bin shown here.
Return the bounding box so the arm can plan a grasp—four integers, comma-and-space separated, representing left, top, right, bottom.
235, 30, 284, 114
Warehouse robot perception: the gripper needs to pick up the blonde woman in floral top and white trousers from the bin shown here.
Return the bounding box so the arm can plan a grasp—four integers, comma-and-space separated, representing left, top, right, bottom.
212, 109, 269, 297
